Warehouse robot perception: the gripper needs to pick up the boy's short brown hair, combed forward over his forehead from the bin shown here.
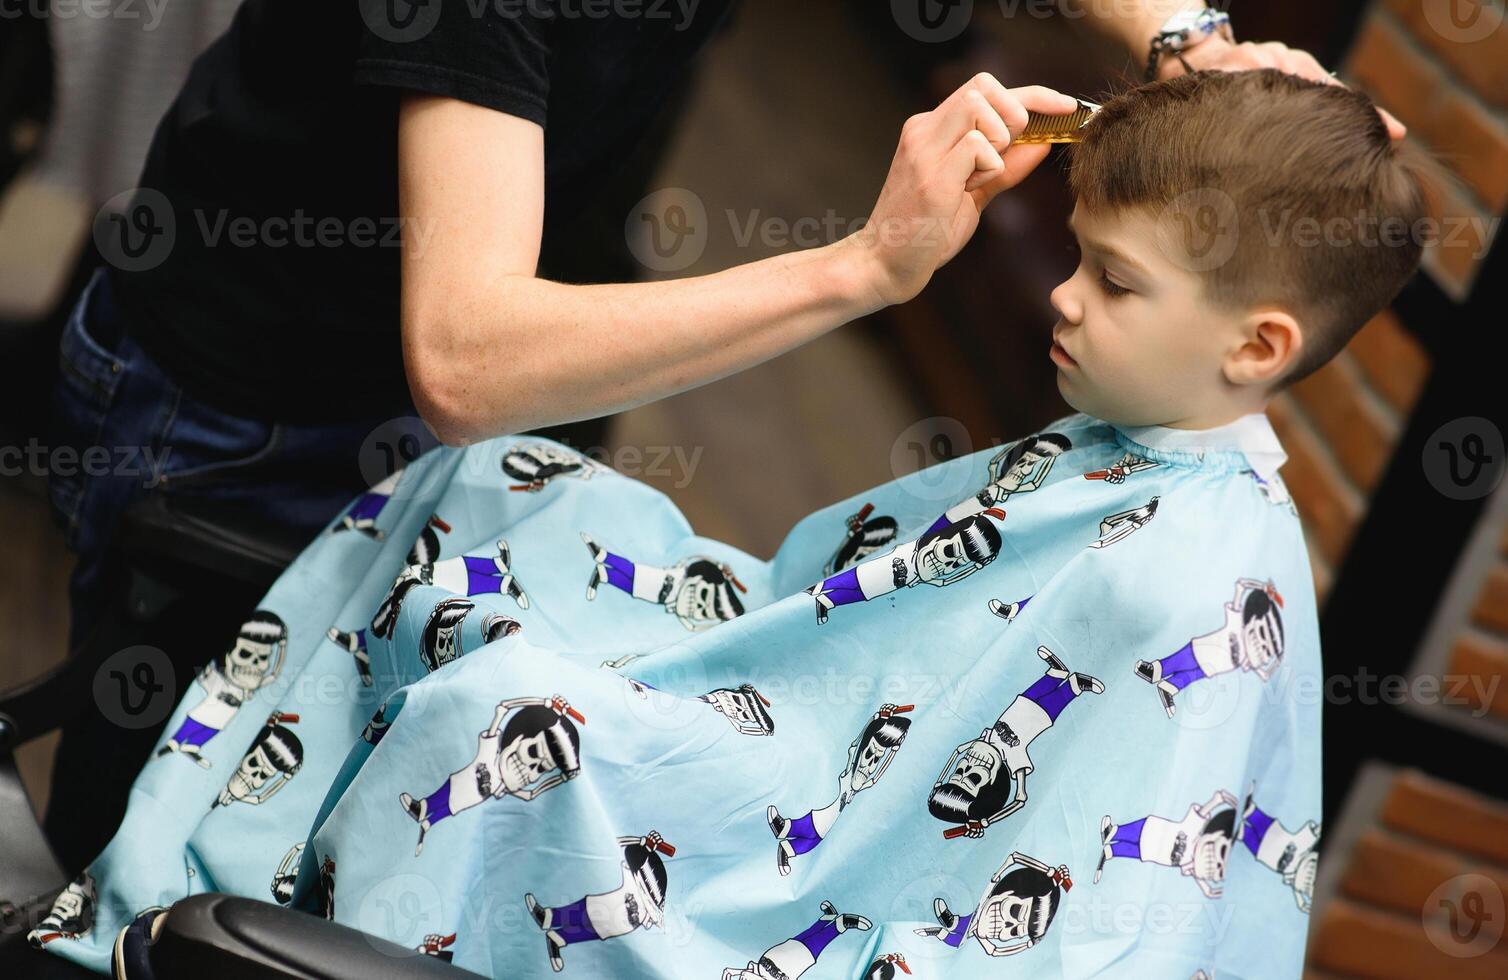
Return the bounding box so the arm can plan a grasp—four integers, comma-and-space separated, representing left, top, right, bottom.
1069, 68, 1431, 387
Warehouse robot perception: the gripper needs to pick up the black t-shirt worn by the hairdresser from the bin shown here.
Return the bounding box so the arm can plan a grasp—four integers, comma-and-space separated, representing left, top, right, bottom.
111, 0, 734, 424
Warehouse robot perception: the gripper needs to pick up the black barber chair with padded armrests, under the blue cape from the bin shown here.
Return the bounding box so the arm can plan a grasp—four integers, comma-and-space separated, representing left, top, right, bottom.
0, 493, 475, 980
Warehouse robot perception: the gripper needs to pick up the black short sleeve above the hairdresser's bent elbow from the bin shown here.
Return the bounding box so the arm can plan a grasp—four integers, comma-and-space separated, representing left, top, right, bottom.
354, 0, 556, 125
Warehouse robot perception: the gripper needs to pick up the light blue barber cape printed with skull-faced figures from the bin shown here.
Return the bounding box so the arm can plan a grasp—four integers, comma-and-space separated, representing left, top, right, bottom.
33, 415, 1320, 980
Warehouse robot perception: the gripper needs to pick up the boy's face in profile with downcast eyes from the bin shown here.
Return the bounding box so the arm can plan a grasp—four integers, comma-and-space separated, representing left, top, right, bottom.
1050, 205, 1240, 427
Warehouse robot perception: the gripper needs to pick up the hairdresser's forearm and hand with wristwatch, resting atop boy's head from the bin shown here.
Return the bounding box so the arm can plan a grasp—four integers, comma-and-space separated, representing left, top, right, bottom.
1062, 0, 1407, 140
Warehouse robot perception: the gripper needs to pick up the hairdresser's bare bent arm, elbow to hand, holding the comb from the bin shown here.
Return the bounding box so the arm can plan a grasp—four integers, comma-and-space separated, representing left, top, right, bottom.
398, 82, 1074, 445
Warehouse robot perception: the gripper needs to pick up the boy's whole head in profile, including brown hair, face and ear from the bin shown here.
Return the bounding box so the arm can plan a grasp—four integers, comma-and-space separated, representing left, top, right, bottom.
1051, 69, 1428, 428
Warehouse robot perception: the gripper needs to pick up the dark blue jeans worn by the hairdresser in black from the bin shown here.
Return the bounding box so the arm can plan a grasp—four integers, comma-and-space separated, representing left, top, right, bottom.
47, 263, 413, 874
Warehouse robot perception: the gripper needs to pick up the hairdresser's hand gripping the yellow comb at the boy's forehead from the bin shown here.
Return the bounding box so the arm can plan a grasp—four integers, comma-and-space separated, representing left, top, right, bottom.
851, 74, 1078, 305
